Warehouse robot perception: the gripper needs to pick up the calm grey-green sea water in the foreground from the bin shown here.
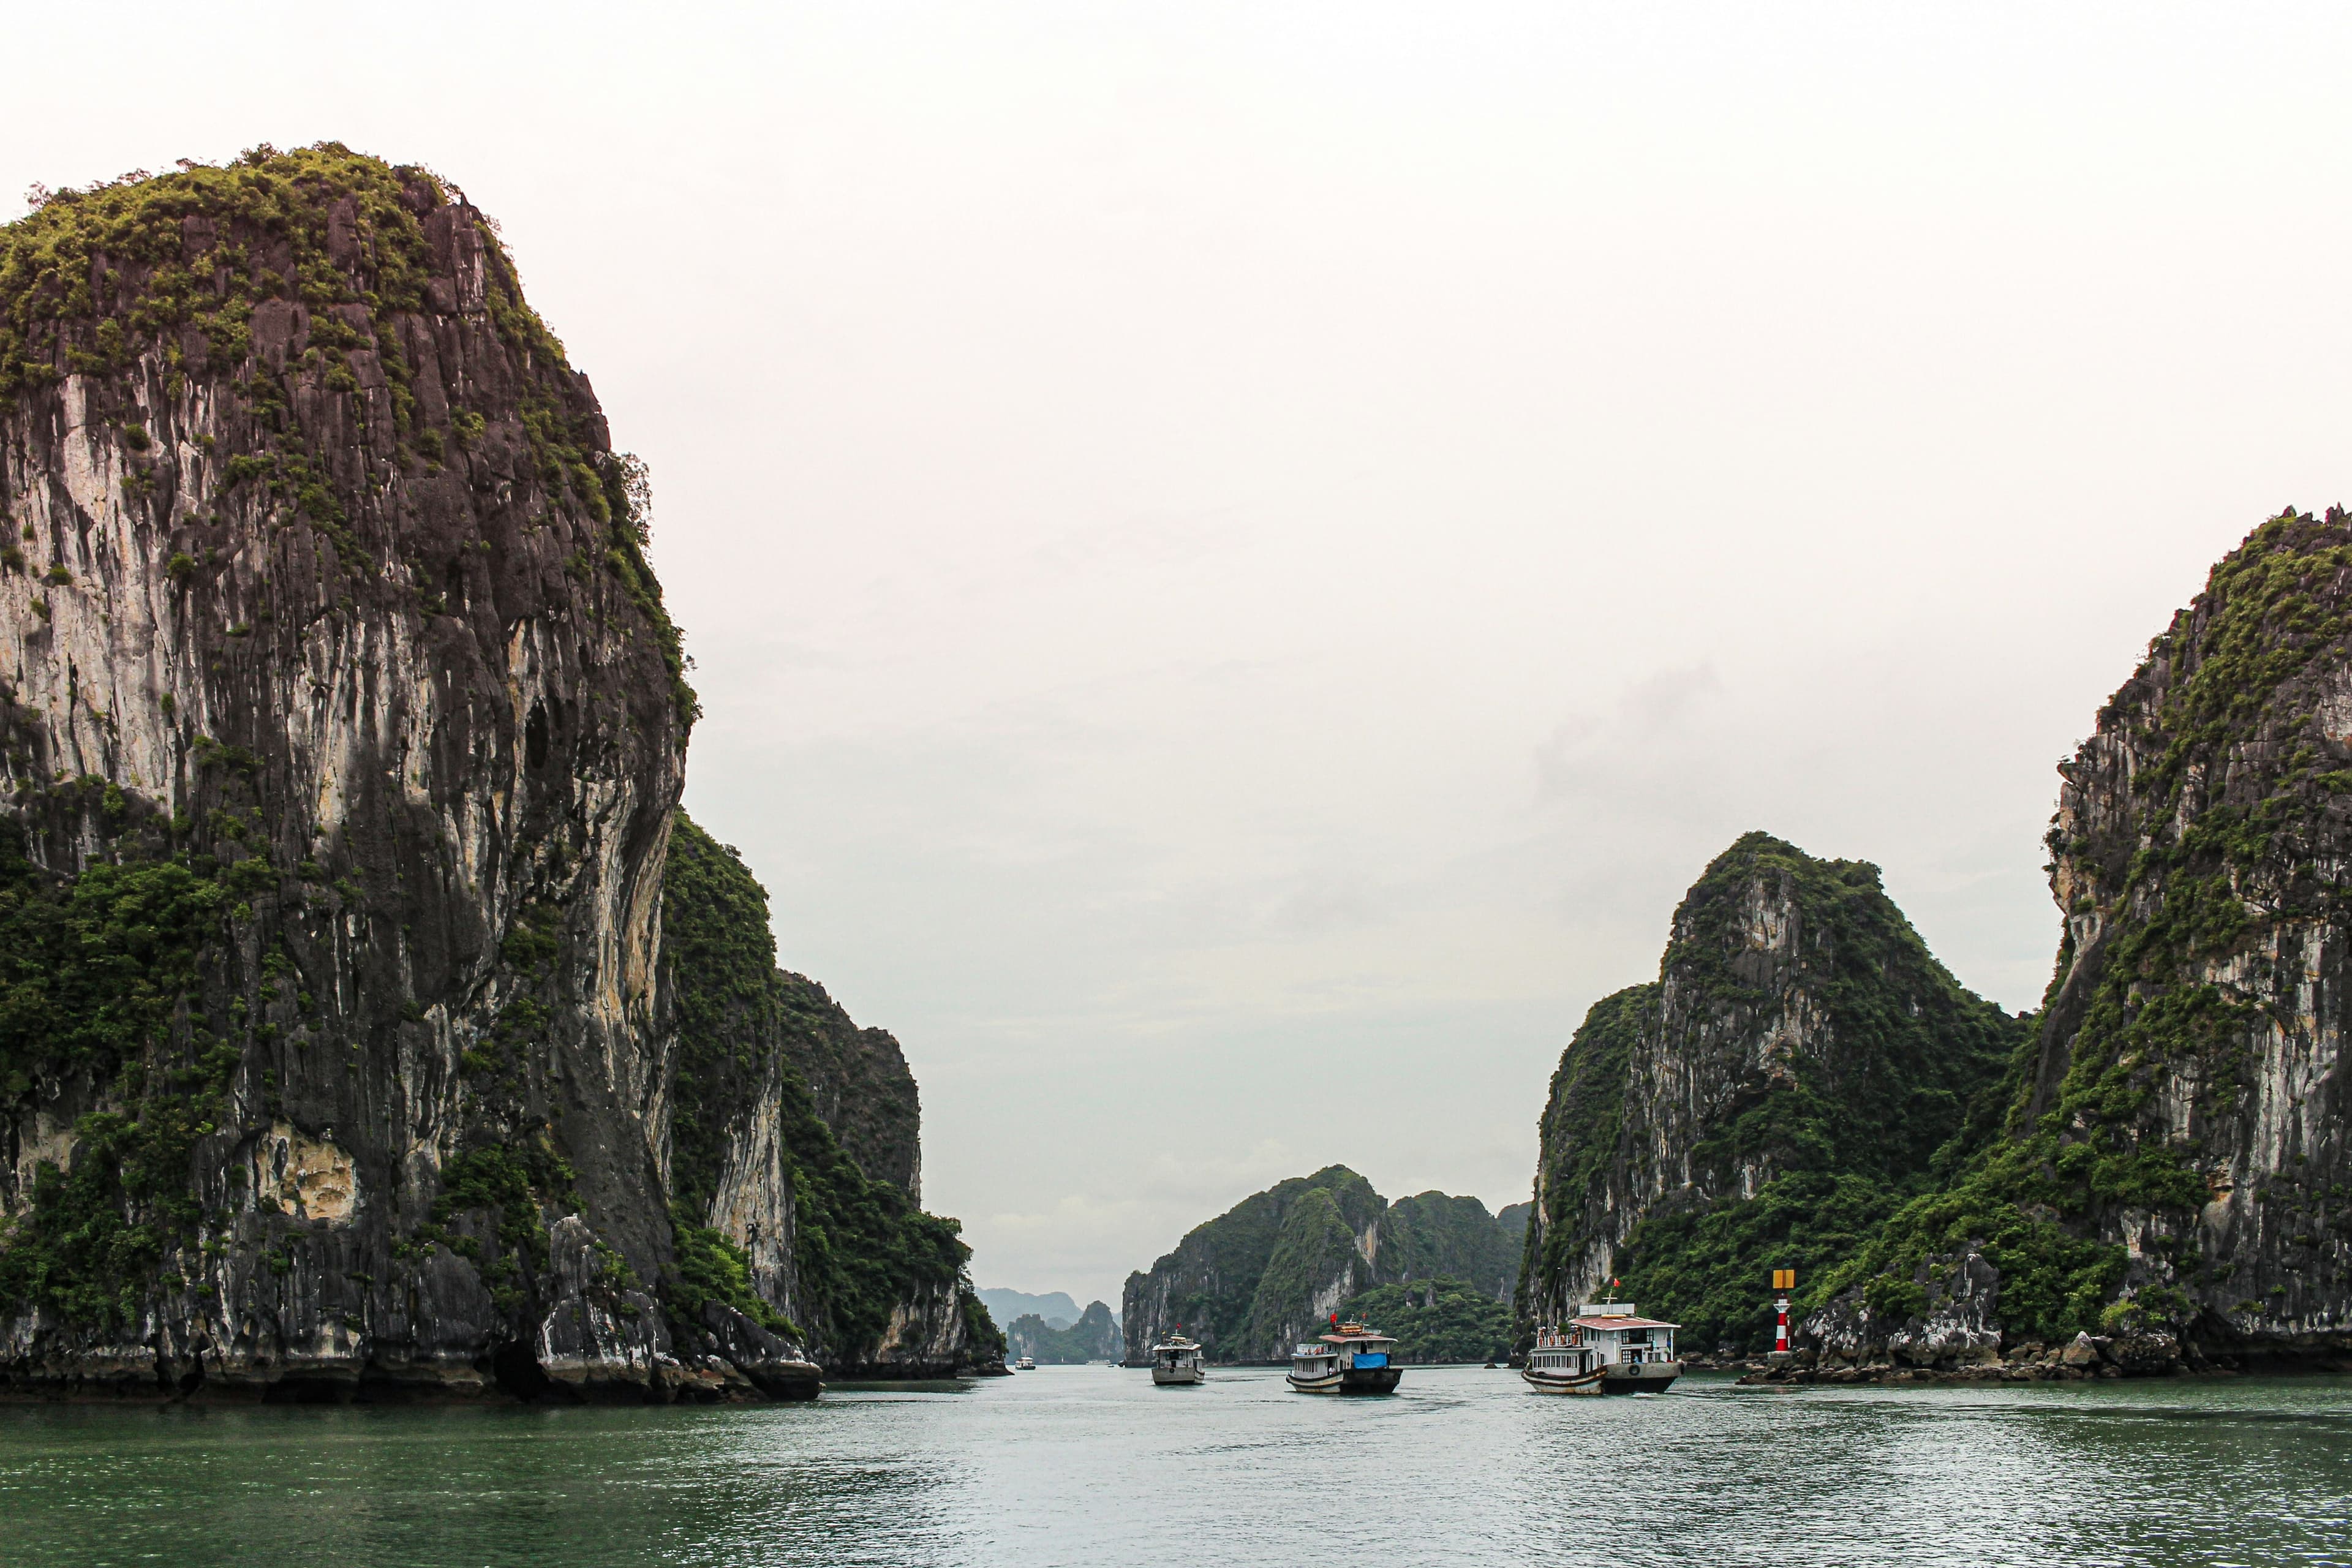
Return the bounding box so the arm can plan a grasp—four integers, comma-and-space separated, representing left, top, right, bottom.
0, 1366, 2352, 1568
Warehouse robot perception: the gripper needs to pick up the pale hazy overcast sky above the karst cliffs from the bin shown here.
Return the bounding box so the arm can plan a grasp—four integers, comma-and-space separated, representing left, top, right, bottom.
0, 0, 2352, 1305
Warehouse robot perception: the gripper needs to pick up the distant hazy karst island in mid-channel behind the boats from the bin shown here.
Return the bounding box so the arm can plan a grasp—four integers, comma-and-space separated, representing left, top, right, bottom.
1120, 1166, 1507, 1366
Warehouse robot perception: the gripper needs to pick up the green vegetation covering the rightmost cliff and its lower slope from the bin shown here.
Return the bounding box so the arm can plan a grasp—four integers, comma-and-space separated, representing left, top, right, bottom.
1818, 513, 2352, 1340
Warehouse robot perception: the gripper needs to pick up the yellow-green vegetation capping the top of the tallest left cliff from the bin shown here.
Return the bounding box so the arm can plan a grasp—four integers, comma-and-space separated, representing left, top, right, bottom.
0, 141, 701, 729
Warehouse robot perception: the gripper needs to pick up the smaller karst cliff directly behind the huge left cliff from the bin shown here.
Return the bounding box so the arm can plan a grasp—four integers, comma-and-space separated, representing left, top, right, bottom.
663, 813, 1005, 1375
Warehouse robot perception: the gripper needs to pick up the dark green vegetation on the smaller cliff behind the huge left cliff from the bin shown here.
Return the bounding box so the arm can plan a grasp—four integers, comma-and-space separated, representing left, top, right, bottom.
661, 811, 992, 1361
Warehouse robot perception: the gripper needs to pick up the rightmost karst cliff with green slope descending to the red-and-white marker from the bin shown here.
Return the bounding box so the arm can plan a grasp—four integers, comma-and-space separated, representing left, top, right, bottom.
1790, 510, 2352, 1375
